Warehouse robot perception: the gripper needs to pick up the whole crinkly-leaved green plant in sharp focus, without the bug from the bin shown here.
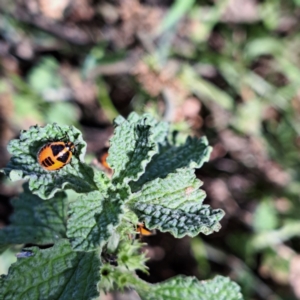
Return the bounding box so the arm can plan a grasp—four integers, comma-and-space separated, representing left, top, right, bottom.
0, 113, 242, 300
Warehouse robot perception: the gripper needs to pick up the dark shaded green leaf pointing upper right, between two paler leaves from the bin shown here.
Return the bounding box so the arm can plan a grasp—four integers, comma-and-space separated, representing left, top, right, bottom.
130, 137, 212, 191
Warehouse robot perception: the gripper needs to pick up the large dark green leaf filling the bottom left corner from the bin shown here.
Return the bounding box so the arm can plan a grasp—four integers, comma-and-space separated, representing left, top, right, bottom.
0, 240, 100, 300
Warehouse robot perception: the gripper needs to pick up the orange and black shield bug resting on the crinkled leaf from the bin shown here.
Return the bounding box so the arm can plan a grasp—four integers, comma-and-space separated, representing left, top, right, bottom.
37, 141, 75, 171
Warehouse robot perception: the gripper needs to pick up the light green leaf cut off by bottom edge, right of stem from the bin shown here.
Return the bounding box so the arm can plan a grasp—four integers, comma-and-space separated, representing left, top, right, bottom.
137, 276, 243, 300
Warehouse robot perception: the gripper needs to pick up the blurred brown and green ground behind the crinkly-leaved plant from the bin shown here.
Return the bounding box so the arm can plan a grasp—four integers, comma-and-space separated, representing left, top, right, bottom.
0, 0, 300, 300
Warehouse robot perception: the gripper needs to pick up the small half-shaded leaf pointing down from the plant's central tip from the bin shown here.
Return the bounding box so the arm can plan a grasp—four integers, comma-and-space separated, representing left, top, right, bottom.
67, 186, 129, 251
